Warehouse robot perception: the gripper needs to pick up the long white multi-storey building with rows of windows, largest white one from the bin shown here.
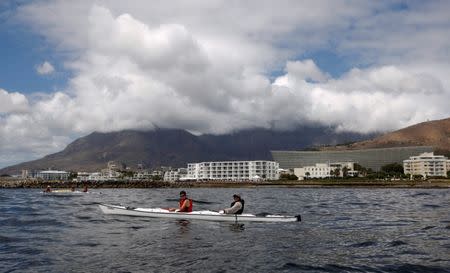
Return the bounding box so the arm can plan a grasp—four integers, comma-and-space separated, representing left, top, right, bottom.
185, 160, 279, 181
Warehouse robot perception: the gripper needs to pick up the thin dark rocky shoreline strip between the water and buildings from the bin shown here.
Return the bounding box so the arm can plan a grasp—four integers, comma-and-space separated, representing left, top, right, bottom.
0, 179, 450, 189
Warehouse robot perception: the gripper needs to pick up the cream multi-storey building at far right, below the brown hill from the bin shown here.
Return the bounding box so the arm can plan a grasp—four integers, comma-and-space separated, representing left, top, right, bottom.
403, 152, 450, 178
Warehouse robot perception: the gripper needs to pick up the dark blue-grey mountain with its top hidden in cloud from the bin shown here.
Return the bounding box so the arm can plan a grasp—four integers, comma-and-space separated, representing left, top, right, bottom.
0, 126, 370, 174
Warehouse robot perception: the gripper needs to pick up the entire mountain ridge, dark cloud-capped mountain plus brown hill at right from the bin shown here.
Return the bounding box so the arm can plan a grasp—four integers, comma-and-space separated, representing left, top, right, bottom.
0, 118, 450, 174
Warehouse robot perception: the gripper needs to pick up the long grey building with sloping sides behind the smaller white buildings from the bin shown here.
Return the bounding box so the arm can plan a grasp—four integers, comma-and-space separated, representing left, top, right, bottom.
271, 146, 433, 171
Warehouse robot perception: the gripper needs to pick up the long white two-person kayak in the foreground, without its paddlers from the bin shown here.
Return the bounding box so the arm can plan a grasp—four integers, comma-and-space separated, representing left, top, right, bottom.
99, 204, 301, 222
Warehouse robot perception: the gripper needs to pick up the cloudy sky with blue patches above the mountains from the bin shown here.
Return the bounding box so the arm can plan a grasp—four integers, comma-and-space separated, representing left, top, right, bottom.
0, 0, 450, 167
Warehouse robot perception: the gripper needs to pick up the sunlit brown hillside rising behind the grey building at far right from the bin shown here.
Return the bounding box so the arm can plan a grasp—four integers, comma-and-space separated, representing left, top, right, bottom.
325, 118, 450, 152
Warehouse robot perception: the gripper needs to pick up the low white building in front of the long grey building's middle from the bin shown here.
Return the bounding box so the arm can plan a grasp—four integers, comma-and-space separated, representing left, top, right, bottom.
294, 162, 358, 180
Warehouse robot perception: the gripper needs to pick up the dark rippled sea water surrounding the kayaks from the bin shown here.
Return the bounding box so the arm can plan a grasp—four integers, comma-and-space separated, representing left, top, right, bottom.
0, 187, 450, 272
